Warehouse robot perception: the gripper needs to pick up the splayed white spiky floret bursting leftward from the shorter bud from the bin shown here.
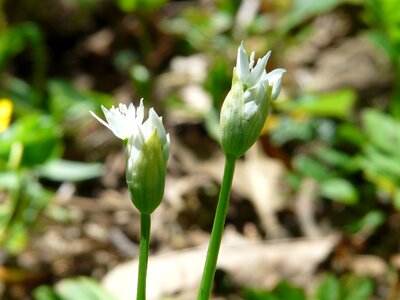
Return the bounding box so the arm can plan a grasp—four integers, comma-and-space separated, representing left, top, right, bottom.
90, 99, 144, 140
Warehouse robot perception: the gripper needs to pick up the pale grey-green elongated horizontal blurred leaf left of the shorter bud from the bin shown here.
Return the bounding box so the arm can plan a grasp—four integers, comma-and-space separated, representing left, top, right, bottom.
37, 159, 103, 181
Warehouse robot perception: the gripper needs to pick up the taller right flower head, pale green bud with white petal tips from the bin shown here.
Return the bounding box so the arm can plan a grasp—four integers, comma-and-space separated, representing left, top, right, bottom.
220, 43, 285, 158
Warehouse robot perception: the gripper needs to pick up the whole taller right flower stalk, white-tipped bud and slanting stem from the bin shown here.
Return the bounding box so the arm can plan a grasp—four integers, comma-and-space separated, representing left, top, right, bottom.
197, 44, 285, 300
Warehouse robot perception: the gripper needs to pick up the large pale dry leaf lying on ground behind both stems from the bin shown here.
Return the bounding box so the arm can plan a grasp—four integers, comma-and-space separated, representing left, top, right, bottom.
103, 236, 338, 300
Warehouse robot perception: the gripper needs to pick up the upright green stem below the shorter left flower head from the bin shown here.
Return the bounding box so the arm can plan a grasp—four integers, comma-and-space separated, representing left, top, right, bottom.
136, 214, 151, 300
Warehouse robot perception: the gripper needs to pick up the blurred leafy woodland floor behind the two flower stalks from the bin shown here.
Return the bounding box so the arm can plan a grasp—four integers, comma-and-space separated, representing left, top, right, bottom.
0, 0, 400, 300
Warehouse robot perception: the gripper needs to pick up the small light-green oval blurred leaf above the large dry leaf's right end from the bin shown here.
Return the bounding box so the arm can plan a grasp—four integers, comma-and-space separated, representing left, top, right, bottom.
320, 178, 358, 205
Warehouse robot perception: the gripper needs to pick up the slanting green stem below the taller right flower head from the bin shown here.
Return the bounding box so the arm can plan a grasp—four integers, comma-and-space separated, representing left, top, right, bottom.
197, 155, 236, 300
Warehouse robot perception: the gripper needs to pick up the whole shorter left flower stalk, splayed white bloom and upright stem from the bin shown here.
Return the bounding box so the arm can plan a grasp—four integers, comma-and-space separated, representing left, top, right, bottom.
91, 100, 170, 300
